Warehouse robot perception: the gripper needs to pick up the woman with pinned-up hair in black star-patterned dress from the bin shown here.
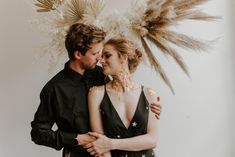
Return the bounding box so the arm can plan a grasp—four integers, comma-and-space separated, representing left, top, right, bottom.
88, 36, 159, 157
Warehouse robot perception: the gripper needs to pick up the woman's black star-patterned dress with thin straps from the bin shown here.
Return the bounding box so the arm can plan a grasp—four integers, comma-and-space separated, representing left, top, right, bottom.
100, 87, 155, 157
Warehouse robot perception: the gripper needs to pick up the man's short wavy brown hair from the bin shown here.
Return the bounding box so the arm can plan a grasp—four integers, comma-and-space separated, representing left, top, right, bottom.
65, 23, 106, 60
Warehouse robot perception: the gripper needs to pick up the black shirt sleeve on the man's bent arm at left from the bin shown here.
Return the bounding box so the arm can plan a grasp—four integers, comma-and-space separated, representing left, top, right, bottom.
31, 86, 77, 150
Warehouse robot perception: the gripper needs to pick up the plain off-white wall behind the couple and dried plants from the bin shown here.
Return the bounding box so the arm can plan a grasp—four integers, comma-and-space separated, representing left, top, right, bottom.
0, 0, 235, 157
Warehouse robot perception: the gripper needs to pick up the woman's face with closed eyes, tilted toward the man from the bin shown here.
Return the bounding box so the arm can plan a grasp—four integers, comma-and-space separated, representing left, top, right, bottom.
101, 45, 122, 75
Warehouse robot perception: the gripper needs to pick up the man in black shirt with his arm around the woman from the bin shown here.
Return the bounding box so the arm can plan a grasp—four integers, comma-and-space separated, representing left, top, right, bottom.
31, 23, 160, 157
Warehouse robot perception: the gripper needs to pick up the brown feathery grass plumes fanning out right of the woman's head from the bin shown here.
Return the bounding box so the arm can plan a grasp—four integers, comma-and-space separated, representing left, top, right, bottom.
130, 0, 218, 91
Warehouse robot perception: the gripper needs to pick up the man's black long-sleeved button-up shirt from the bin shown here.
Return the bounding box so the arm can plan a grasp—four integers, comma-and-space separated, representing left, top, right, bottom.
31, 63, 105, 157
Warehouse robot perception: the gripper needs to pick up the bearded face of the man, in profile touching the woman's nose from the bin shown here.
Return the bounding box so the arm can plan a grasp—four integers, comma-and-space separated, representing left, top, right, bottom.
80, 42, 103, 69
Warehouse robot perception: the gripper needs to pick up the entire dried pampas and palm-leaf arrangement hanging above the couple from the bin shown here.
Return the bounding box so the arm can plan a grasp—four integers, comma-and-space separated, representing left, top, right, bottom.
35, 0, 219, 93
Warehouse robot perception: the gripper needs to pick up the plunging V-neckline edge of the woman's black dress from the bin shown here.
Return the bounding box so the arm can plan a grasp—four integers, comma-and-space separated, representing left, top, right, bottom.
105, 86, 143, 131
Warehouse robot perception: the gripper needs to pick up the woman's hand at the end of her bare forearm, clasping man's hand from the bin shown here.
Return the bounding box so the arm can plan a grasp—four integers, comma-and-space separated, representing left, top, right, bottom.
83, 132, 112, 156
